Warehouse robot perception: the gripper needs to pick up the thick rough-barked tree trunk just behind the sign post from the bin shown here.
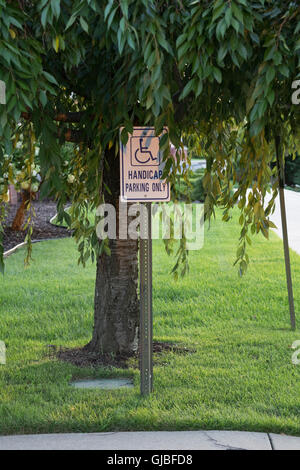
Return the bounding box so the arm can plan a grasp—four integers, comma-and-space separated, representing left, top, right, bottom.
86, 148, 139, 355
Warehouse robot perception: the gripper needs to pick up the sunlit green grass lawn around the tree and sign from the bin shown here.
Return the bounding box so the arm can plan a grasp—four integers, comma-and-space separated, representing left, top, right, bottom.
0, 210, 300, 435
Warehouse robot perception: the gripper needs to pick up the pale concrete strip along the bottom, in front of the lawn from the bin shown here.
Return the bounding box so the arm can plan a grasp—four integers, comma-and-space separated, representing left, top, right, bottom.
0, 431, 300, 450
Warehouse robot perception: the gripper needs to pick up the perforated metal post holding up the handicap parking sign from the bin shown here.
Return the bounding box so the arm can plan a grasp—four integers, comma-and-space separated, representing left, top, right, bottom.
140, 202, 153, 395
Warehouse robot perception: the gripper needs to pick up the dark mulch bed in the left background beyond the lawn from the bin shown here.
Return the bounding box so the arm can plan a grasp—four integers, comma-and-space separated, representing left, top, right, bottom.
4, 201, 71, 251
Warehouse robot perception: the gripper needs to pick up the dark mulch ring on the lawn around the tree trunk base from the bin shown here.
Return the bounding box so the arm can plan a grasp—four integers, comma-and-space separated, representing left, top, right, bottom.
54, 341, 195, 369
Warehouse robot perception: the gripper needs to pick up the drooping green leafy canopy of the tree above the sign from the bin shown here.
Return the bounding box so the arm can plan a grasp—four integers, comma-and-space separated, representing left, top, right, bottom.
0, 0, 300, 273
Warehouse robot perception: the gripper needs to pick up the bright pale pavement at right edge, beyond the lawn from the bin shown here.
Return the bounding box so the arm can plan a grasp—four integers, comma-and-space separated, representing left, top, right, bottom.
264, 189, 300, 255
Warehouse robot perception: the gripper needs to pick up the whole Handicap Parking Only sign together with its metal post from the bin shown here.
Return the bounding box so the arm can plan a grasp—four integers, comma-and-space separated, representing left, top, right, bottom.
120, 127, 170, 395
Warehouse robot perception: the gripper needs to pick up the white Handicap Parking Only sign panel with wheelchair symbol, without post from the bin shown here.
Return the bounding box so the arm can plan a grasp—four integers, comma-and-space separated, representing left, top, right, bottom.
120, 127, 170, 202
